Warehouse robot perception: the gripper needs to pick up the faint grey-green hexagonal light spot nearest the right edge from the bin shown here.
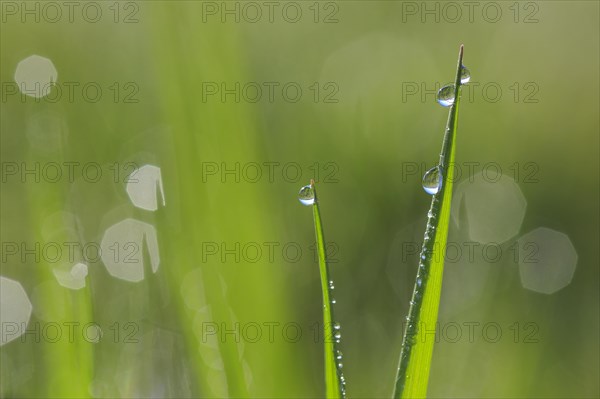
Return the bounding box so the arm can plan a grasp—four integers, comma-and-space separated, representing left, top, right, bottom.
517, 227, 577, 294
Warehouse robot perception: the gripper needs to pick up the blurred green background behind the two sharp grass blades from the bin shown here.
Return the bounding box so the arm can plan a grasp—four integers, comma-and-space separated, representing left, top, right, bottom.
0, 1, 600, 398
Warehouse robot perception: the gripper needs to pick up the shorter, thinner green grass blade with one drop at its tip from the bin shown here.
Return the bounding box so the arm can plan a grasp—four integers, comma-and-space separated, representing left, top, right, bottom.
310, 180, 346, 398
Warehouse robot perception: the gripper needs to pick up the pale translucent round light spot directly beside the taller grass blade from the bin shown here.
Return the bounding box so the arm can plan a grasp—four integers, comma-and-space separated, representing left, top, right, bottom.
452, 172, 527, 244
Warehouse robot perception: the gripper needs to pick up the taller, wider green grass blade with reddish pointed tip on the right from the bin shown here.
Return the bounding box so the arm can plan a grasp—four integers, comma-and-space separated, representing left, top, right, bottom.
394, 46, 463, 398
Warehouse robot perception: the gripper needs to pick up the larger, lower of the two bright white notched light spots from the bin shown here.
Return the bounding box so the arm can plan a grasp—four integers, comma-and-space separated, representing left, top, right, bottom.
100, 219, 160, 282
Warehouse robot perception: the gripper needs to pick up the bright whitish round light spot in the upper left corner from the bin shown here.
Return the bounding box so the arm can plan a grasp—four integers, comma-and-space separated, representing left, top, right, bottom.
15, 55, 58, 98
